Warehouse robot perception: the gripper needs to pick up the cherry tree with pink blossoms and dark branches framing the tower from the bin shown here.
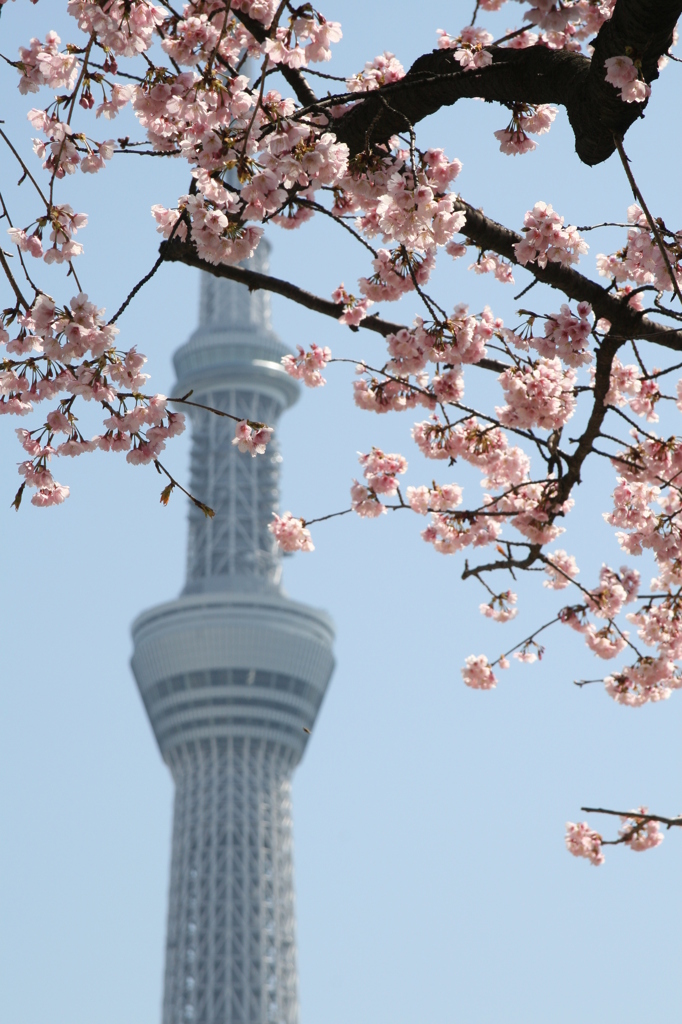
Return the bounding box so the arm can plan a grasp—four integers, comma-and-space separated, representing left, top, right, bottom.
0, 0, 682, 864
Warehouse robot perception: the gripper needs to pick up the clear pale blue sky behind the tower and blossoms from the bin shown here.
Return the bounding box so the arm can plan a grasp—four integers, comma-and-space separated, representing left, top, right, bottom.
0, 0, 682, 1024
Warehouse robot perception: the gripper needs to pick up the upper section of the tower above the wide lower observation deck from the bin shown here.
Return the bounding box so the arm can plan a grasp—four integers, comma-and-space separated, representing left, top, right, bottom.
173, 243, 298, 594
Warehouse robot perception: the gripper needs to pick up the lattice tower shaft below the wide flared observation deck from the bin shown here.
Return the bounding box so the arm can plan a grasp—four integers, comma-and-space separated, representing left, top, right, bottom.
164, 737, 298, 1024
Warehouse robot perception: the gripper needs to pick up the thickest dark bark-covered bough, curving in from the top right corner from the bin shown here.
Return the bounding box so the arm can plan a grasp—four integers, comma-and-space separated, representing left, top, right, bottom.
334, 0, 682, 165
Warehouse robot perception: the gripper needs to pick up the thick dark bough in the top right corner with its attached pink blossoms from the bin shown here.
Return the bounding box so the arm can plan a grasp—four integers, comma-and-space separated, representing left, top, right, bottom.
323, 0, 682, 165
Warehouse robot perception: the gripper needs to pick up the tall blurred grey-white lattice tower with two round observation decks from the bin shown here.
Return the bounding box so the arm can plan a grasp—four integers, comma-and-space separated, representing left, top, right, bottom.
132, 243, 334, 1024
